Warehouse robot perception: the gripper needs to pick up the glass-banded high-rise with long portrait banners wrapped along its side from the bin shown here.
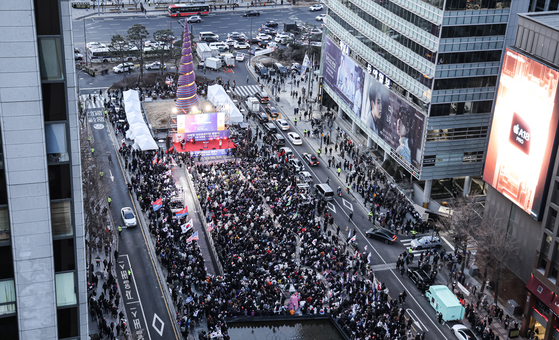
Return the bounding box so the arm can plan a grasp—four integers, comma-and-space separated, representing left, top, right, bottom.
321, 0, 529, 206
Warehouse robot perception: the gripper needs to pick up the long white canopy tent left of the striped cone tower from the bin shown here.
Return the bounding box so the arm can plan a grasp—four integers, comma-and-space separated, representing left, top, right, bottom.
124, 90, 159, 151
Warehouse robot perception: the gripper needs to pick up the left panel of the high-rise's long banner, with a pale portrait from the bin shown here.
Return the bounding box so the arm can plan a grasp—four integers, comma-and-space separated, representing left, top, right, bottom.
323, 37, 365, 117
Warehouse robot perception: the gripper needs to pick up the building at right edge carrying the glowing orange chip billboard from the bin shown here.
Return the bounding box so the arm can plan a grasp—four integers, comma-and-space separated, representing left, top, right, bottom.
483, 10, 559, 340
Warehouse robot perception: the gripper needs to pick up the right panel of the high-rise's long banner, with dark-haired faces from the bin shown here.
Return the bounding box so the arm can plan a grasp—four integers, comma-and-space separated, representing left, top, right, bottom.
360, 74, 425, 169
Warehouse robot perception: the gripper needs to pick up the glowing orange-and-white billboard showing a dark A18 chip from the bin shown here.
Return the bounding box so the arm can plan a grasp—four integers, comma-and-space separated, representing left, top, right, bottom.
483, 48, 559, 220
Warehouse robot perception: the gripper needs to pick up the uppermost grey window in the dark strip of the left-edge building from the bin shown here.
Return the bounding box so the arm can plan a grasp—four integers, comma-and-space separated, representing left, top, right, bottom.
39, 37, 64, 80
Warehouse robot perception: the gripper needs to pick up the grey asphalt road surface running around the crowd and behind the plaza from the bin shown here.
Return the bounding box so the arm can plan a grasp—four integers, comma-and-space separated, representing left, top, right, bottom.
74, 7, 460, 339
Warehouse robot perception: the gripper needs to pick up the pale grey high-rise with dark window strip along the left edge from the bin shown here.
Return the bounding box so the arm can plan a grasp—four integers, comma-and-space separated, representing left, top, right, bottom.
0, 0, 88, 340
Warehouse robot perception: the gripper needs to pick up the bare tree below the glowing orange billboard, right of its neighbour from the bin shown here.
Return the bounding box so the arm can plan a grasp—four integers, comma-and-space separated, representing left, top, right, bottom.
472, 213, 518, 303
